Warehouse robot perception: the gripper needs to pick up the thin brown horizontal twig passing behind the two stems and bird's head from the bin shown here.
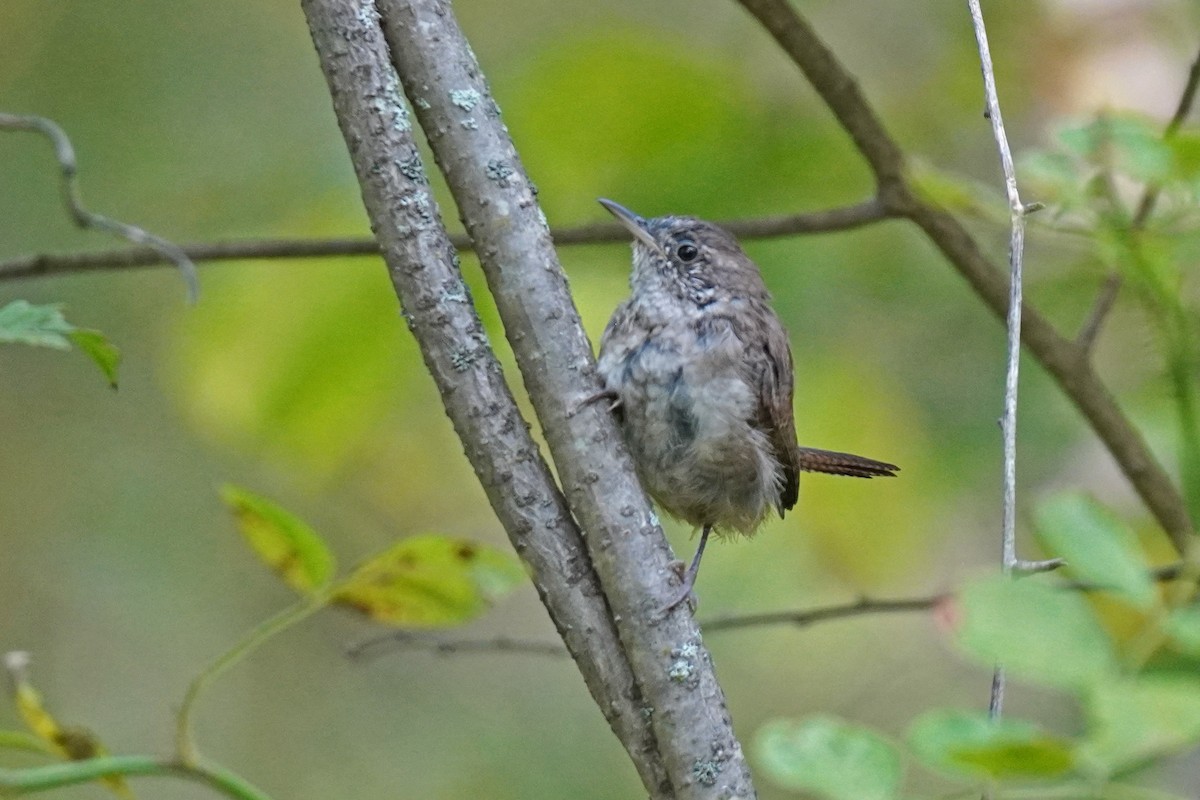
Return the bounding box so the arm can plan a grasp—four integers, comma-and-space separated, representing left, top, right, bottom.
0, 198, 890, 279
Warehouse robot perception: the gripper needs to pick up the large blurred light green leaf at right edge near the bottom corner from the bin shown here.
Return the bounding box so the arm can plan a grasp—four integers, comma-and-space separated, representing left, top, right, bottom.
1085, 674, 1200, 772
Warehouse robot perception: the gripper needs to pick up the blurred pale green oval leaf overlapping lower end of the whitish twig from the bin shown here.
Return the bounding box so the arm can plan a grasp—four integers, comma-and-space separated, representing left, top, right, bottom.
959, 576, 1117, 687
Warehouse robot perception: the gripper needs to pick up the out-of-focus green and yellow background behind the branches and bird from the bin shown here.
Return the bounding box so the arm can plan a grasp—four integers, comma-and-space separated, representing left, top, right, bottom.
0, 0, 1198, 800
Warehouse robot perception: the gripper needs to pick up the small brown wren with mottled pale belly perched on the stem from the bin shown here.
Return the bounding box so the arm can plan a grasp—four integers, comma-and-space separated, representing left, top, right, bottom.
599, 199, 899, 608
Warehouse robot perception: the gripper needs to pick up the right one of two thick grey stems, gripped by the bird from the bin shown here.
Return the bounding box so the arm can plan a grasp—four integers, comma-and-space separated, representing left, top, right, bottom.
378, 0, 755, 800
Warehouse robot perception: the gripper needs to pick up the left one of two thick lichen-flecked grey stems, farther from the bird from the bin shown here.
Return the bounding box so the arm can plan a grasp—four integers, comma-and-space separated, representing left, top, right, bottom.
302, 0, 671, 798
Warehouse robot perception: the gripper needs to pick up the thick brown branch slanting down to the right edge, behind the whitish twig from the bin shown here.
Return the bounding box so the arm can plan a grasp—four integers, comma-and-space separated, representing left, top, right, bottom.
739, 0, 1194, 553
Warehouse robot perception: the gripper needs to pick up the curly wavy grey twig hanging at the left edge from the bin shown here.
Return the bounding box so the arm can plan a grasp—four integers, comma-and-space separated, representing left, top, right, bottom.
0, 114, 200, 302
